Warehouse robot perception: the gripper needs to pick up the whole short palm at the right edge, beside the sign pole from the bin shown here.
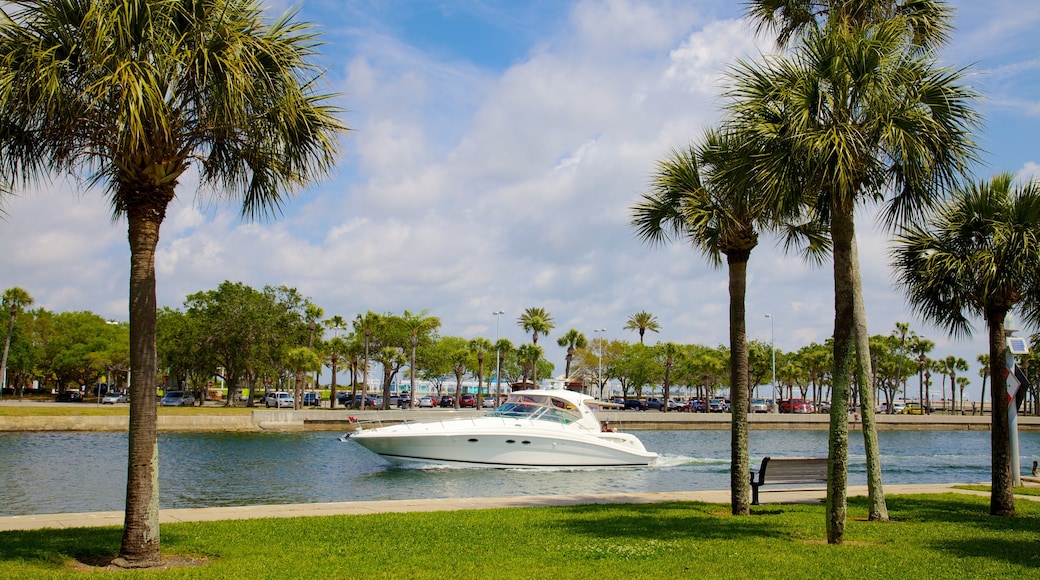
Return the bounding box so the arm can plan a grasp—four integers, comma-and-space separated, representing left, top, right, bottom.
892, 173, 1040, 516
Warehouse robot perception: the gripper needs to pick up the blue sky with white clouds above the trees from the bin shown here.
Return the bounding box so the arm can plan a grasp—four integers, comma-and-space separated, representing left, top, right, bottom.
0, 0, 1040, 399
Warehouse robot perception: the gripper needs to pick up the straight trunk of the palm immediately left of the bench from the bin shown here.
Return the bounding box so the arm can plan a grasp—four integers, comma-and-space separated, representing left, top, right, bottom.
727, 253, 751, 516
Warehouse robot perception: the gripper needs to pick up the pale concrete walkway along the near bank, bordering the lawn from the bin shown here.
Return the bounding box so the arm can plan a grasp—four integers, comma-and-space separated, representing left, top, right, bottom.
0, 482, 1040, 531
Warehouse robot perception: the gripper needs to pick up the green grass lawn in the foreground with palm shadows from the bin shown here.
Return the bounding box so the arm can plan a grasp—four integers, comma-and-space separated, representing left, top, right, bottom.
0, 494, 1040, 580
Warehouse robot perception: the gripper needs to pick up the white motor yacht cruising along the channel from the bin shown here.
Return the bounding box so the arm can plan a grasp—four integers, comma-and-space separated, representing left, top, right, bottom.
344, 390, 657, 468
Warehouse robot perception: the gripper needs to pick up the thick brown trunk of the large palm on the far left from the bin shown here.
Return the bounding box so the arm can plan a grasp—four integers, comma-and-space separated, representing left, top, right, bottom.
113, 201, 164, 568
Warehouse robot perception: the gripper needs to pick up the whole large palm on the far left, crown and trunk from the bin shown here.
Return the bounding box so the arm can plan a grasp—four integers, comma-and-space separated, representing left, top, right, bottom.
0, 0, 345, 566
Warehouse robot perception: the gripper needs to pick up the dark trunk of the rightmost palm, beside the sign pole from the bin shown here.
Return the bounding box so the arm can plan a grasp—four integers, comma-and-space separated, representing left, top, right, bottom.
986, 308, 1015, 516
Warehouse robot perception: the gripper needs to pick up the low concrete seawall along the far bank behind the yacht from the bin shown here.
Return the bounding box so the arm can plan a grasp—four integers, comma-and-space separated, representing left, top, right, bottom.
0, 410, 1040, 431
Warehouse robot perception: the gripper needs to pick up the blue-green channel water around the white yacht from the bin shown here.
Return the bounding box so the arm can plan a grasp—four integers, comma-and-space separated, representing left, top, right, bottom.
0, 430, 1040, 517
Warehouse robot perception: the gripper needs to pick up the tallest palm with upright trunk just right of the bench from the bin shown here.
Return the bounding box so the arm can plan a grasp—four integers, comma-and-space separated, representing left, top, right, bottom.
727, 0, 978, 544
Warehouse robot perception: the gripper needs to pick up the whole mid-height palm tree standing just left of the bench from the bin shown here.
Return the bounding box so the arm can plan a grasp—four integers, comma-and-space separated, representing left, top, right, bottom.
626, 132, 820, 516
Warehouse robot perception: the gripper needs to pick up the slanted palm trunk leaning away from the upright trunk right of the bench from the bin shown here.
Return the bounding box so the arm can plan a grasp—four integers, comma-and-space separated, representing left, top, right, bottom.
846, 232, 888, 522
